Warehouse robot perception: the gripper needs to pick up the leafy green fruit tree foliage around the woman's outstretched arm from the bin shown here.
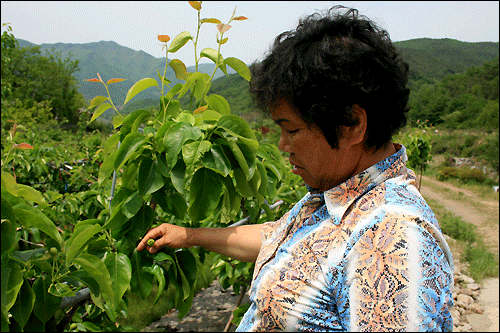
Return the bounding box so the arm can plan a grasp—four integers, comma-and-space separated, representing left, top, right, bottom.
1, 2, 305, 331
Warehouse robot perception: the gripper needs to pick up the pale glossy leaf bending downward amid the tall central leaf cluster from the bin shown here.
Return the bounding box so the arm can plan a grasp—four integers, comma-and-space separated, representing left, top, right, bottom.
163, 122, 202, 169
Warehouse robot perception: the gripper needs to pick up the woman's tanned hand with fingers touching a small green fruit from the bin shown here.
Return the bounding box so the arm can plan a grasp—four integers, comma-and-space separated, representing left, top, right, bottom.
137, 223, 193, 253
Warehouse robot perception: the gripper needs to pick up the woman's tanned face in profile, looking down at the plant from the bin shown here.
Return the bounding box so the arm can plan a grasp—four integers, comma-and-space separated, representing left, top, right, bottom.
270, 100, 363, 191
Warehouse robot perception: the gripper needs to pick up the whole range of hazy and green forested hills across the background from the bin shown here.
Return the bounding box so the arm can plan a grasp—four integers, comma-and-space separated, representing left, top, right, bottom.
7, 38, 499, 130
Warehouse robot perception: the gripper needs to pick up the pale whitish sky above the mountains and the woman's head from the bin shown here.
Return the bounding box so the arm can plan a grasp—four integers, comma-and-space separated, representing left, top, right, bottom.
1, 1, 499, 66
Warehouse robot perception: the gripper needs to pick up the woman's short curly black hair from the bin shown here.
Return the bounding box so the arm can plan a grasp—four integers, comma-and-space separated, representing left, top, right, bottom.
250, 6, 409, 148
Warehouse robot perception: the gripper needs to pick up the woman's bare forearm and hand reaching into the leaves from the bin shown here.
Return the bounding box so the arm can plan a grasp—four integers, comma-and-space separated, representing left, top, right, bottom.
137, 223, 262, 262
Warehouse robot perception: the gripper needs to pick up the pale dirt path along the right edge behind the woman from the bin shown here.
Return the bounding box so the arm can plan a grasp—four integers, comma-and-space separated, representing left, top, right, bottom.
420, 177, 499, 332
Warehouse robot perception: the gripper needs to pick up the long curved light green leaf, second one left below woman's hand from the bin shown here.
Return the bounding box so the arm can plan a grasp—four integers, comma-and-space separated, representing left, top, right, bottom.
73, 253, 116, 308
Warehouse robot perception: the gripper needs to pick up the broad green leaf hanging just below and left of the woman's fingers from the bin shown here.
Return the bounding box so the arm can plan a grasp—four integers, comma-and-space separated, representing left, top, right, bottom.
104, 252, 132, 304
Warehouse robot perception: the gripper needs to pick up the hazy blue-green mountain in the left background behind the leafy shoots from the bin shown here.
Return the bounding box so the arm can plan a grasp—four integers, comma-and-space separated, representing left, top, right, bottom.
17, 39, 235, 106
